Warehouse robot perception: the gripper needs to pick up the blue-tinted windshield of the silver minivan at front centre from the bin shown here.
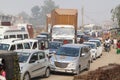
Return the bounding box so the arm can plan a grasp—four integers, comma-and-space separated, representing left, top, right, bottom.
56, 47, 79, 57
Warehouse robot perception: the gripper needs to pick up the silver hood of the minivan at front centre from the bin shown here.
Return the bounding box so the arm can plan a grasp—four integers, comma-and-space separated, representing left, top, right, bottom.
51, 55, 77, 62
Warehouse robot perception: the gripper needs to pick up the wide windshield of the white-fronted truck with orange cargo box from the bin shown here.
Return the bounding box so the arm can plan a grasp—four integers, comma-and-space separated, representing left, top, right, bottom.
52, 27, 75, 35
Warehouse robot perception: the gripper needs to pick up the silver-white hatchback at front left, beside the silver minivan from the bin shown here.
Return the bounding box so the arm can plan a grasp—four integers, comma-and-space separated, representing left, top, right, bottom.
15, 49, 50, 80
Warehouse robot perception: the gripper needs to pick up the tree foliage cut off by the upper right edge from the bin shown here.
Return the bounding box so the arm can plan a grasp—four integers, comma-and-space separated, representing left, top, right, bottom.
111, 5, 120, 27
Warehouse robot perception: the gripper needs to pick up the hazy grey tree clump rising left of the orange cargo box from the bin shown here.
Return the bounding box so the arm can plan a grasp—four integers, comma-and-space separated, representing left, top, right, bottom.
31, 0, 58, 26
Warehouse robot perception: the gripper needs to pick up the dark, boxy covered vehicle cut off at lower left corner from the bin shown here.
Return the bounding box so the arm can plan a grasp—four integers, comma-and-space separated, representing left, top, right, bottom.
0, 50, 20, 80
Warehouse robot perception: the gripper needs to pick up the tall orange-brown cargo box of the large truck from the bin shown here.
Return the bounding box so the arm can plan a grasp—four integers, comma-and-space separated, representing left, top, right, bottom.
51, 9, 78, 30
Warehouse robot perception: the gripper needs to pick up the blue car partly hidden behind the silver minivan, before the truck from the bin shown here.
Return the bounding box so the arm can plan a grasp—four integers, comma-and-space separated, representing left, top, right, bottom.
49, 41, 63, 54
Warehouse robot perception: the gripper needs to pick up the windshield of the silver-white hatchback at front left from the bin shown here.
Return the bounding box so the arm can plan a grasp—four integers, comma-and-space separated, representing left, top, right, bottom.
17, 52, 30, 63
